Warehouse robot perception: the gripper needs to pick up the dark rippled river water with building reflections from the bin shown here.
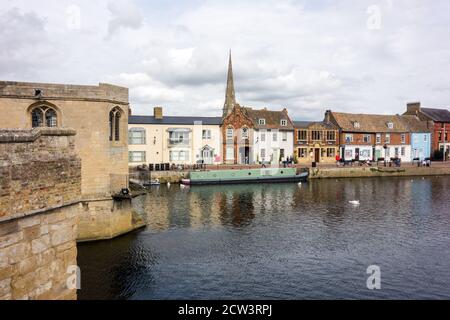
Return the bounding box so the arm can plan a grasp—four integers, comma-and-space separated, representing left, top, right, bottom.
78, 177, 450, 299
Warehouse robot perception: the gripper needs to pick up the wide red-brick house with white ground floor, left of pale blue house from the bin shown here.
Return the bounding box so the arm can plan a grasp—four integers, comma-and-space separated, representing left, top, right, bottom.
326, 111, 412, 162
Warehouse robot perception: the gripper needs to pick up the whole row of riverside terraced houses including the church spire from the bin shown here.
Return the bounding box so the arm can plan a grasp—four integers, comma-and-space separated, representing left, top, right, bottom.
129, 57, 450, 166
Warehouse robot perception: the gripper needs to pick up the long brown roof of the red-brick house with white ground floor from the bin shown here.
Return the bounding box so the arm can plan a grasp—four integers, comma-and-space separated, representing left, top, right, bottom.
331, 112, 409, 133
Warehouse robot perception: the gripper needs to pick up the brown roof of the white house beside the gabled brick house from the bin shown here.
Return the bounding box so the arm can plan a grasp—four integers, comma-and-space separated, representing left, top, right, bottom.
243, 107, 294, 130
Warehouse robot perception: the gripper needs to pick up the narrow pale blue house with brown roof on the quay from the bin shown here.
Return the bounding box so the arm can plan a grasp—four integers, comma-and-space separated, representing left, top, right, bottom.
401, 115, 431, 161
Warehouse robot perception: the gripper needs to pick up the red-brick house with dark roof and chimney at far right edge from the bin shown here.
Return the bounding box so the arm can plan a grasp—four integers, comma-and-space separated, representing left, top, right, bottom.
405, 102, 450, 159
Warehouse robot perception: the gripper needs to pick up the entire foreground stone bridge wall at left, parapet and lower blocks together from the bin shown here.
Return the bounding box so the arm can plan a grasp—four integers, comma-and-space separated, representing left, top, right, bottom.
0, 129, 81, 300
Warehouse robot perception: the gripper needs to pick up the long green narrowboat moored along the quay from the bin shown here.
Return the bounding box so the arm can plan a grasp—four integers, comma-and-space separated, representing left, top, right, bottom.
181, 168, 308, 185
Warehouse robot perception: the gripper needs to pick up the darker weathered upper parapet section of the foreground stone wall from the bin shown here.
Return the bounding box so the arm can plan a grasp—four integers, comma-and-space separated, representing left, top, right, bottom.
0, 129, 81, 221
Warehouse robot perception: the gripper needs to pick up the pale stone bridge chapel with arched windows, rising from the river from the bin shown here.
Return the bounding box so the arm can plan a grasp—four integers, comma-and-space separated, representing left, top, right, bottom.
0, 82, 142, 240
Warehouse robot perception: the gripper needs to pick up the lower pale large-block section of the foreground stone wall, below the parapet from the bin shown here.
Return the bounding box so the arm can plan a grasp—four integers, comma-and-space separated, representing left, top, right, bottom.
0, 205, 79, 300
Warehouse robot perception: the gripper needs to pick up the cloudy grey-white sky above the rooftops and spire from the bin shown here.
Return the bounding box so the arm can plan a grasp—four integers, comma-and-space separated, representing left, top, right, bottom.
0, 0, 450, 120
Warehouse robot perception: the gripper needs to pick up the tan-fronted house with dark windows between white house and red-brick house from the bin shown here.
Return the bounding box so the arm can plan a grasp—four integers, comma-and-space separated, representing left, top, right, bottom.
294, 121, 339, 164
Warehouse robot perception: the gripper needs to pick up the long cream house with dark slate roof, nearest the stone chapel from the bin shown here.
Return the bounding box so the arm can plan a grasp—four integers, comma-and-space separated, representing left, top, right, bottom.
128, 107, 222, 166
